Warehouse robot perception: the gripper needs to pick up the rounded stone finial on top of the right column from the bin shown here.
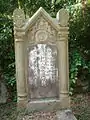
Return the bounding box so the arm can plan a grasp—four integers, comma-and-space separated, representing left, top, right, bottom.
57, 8, 69, 26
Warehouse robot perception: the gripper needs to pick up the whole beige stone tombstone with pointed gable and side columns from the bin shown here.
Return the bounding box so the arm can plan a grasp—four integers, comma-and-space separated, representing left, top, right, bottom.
13, 7, 70, 111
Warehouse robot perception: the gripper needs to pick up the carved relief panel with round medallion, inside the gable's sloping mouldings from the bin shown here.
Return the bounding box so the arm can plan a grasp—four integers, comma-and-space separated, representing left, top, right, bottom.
28, 17, 56, 42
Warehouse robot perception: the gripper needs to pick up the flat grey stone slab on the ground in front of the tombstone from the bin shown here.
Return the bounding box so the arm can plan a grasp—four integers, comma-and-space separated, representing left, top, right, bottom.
57, 110, 77, 120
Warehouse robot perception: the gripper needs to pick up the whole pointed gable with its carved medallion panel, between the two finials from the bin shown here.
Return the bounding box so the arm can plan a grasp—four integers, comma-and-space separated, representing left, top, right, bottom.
25, 7, 59, 42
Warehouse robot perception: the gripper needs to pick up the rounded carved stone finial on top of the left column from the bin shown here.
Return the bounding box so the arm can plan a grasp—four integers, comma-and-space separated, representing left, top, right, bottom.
13, 8, 25, 28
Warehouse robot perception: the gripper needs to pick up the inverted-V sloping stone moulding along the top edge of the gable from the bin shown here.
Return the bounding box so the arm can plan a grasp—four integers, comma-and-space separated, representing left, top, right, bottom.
25, 7, 59, 31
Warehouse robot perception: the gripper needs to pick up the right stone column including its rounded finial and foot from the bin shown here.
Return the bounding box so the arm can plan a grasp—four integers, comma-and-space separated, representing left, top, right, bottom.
57, 9, 70, 108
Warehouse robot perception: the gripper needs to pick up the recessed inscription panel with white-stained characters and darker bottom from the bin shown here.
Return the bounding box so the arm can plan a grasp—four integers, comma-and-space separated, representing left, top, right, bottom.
28, 44, 58, 98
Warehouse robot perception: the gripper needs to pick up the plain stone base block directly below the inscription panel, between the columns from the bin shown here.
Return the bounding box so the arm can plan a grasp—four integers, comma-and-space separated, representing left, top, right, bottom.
27, 100, 61, 113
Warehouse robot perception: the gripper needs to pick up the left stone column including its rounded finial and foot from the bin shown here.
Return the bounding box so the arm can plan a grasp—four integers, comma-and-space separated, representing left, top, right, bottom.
13, 9, 27, 108
